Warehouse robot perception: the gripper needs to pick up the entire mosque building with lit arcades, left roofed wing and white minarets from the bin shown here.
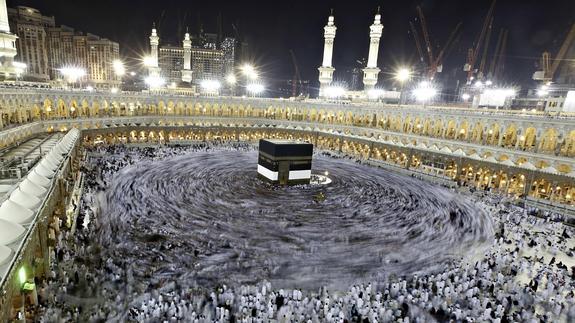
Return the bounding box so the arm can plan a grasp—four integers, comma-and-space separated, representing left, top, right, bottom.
0, 1, 575, 322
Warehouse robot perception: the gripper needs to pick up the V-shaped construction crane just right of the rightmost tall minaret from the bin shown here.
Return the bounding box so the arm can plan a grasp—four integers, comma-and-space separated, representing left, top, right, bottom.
409, 6, 462, 79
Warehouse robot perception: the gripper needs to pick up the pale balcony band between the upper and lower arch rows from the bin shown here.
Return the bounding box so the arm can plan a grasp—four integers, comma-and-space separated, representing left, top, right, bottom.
0, 116, 575, 180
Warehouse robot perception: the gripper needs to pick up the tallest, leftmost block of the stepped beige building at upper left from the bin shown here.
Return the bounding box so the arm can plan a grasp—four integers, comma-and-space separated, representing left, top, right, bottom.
8, 6, 55, 81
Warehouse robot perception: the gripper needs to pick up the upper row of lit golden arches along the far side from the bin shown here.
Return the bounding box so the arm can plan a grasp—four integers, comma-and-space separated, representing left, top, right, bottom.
1, 99, 575, 157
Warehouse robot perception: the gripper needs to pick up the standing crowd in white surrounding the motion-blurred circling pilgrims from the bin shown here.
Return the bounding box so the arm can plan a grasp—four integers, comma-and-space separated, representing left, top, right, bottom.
39, 143, 575, 322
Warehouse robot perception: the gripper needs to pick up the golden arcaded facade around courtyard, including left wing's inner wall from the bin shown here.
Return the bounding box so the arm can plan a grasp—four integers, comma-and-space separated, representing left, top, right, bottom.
0, 90, 575, 319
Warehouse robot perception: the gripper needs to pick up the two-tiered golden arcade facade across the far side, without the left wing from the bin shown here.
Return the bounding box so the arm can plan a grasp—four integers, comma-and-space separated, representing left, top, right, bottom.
0, 91, 575, 209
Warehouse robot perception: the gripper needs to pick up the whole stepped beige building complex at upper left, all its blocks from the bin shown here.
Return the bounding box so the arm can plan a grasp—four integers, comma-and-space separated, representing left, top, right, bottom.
6, 6, 120, 88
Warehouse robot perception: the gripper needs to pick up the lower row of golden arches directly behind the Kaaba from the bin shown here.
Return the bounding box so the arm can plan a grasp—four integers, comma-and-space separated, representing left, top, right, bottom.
84, 127, 575, 205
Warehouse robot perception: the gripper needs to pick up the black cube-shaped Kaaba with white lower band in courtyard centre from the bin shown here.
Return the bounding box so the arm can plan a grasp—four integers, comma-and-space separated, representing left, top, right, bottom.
258, 139, 313, 185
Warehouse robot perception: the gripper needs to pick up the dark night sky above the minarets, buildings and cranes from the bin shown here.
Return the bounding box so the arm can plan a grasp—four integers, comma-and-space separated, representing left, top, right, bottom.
8, 0, 575, 91
